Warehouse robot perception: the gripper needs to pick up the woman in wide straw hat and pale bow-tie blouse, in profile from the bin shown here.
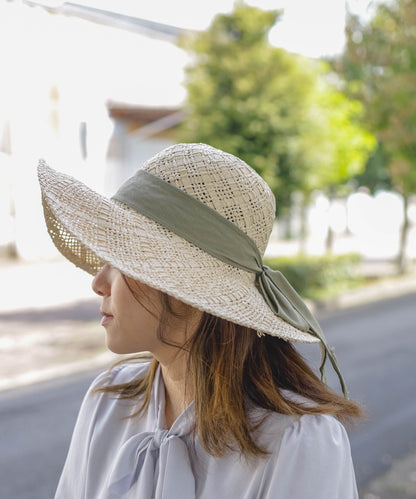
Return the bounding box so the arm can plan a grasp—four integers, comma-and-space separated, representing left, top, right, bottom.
39, 144, 361, 499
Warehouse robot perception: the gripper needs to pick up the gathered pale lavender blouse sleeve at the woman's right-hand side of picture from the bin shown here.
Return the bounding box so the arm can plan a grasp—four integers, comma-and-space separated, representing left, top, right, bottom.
264, 415, 358, 499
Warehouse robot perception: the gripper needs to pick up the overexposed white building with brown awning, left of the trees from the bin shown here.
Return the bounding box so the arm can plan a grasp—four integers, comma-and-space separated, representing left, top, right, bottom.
0, 1, 187, 259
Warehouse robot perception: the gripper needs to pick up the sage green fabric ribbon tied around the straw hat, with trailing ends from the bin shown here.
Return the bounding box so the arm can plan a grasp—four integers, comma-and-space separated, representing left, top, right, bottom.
112, 170, 347, 397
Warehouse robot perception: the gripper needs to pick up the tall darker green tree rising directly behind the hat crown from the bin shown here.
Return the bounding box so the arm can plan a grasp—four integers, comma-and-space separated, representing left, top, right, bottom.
176, 4, 314, 215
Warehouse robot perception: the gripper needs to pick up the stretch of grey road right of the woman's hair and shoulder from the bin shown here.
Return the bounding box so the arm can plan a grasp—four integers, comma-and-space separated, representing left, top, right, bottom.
312, 294, 416, 485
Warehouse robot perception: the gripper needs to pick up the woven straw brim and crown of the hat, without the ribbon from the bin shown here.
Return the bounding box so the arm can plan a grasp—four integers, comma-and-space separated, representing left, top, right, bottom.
38, 144, 319, 343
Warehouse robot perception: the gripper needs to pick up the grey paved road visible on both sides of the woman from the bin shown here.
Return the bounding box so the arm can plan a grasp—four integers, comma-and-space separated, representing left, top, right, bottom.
0, 294, 416, 499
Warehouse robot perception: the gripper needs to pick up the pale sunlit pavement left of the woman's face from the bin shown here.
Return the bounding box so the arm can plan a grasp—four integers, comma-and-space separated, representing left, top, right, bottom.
0, 260, 117, 390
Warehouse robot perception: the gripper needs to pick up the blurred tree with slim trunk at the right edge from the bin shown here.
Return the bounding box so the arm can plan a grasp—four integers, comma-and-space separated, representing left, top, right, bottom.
336, 0, 416, 272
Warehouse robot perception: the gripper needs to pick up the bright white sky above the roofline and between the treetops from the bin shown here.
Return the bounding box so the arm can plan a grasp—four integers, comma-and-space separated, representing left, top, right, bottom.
60, 0, 375, 57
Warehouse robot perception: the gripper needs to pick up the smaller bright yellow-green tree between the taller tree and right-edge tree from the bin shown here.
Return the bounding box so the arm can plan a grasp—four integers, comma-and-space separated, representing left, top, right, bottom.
299, 63, 376, 252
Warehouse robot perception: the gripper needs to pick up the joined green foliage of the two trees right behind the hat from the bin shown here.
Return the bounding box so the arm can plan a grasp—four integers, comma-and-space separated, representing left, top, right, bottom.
180, 4, 372, 215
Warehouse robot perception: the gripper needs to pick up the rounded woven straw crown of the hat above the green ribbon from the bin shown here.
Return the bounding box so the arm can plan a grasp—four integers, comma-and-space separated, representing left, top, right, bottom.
143, 144, 275, 255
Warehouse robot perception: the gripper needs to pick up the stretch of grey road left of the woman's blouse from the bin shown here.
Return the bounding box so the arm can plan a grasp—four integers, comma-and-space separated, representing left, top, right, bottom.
0, 372, 97, 499
